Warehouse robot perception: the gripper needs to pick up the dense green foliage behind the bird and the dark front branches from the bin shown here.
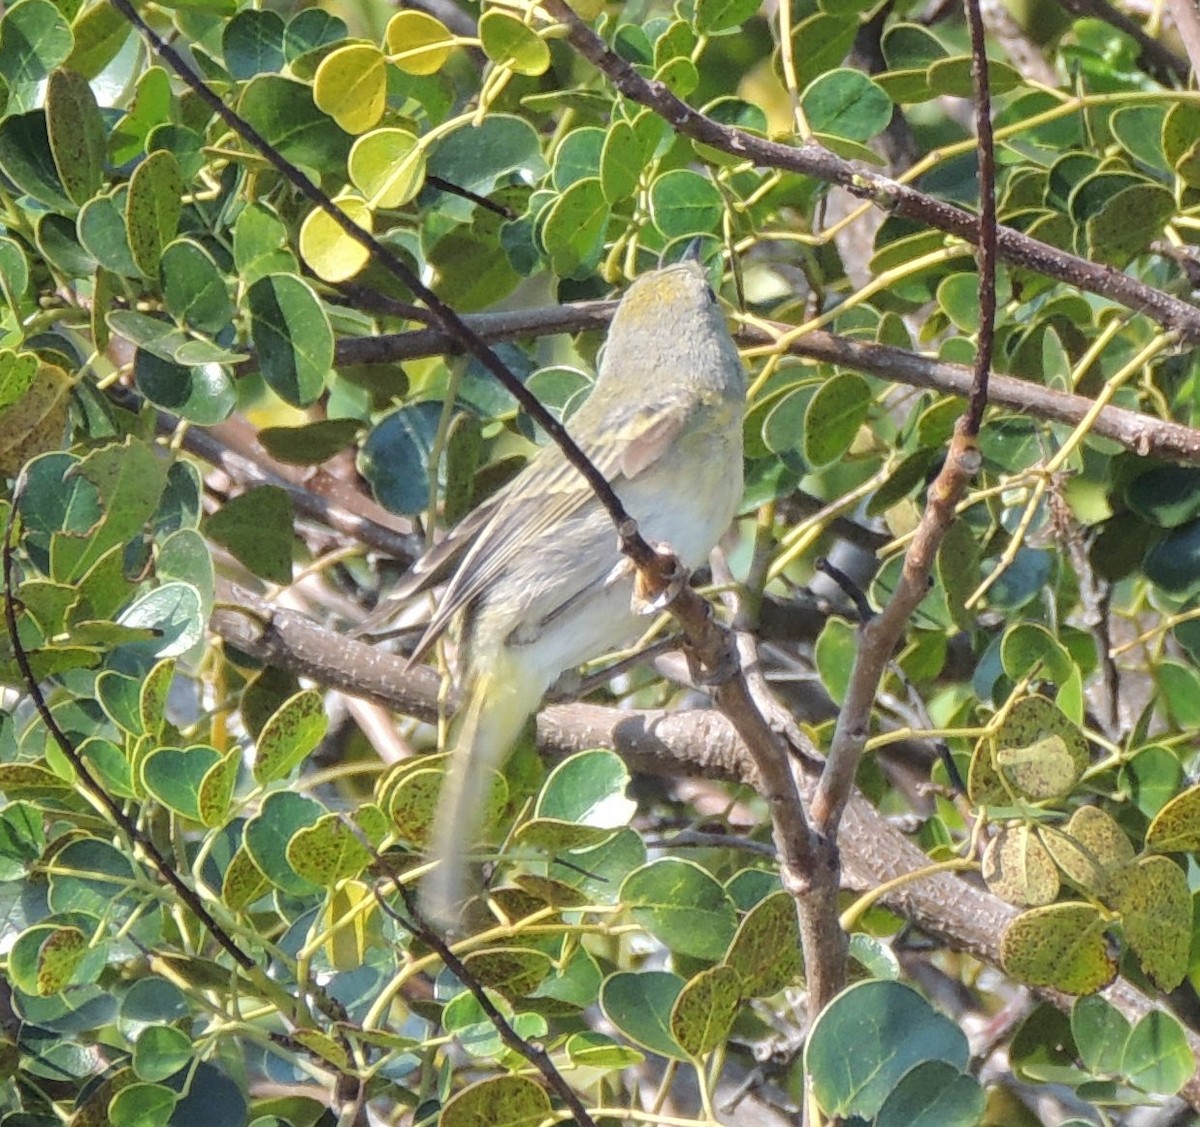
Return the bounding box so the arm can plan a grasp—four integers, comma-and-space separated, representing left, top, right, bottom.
0, 0, 1200, 1127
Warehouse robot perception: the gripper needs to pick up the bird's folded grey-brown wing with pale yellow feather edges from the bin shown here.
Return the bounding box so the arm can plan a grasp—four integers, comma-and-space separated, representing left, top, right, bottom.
410, 398, 690, 661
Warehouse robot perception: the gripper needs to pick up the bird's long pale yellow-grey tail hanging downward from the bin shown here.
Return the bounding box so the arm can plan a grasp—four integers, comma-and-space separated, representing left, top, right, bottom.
420, 648, 545, 930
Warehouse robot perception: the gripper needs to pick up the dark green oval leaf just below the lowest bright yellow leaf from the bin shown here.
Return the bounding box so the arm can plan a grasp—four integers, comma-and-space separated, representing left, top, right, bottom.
246, 274, 334, 407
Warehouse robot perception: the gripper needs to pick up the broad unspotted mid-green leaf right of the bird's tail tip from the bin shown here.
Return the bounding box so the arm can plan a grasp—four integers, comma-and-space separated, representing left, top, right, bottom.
620, 857, 737, 961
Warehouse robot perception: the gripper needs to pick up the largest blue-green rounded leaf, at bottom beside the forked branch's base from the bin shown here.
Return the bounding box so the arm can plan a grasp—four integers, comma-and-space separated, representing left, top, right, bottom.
804, 981, 970, 1120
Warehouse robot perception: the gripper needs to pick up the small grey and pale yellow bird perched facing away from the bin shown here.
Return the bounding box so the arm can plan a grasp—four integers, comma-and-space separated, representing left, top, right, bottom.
374, 262, 745, 925
